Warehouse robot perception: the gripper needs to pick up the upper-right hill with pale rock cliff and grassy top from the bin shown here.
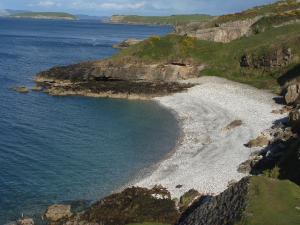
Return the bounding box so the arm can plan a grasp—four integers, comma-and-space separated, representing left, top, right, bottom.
175, 0, 300, 43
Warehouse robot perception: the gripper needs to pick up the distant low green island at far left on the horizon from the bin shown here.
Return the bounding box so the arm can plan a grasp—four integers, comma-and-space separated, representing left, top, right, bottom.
9, 12, 77, 20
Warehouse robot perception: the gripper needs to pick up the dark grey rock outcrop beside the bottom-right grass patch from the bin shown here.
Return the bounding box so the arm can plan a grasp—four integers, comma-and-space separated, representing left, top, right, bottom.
177, 177, 250, 225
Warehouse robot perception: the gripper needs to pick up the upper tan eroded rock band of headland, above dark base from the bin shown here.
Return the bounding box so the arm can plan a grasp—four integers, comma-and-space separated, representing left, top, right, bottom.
37, 61, 203, 82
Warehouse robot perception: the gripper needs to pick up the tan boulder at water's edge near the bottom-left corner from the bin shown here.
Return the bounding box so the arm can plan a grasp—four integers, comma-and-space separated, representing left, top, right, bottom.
45, 205, 72, 222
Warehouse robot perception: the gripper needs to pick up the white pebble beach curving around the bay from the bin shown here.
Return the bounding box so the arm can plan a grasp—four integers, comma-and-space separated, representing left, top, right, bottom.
134, 77, 285, 198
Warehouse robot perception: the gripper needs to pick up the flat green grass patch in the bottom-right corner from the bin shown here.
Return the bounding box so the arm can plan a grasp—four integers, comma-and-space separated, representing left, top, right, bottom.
238, 177, 300, 225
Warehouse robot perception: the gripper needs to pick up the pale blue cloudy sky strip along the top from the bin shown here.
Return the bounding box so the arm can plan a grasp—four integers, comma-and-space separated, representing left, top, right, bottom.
0, 0, 276, 16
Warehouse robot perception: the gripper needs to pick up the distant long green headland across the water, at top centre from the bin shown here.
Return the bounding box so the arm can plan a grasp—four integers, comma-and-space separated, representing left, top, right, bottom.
108, 14, 213, 25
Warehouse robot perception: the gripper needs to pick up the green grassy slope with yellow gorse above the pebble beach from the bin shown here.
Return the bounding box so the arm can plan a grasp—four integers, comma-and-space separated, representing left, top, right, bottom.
113, 24, 300, 92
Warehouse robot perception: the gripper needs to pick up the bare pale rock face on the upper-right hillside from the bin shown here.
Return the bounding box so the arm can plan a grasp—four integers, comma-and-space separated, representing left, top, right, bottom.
176, 18, 258, 43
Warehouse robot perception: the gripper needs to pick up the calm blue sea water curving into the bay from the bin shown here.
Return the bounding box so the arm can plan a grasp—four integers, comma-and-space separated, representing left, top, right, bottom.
0, 19, 178, 224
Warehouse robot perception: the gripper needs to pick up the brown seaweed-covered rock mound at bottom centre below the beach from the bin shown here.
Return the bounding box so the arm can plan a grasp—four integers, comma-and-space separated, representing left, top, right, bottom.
59, 186, 179, 225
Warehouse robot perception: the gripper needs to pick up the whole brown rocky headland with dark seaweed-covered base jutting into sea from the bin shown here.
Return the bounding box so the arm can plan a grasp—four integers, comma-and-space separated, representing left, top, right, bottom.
36, 61, 201, 99
